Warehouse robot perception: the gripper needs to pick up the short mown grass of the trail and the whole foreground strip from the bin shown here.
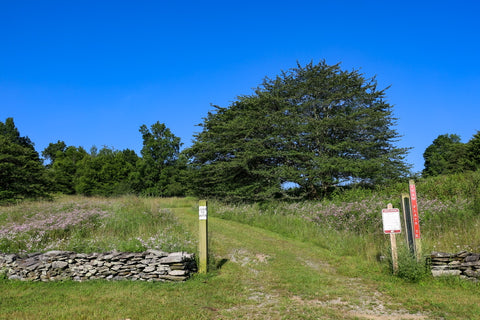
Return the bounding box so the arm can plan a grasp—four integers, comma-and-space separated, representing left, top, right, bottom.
0, 200, 480, 320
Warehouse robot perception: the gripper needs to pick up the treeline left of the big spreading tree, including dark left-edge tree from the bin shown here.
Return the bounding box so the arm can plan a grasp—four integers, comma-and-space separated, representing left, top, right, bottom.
0, 118, 187, 202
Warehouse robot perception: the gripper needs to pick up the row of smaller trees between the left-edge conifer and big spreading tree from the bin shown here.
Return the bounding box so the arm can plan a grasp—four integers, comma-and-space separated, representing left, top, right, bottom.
37, 122, 187, 196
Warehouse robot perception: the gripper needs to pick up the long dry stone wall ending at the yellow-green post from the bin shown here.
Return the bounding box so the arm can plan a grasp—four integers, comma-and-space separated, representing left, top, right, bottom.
0, 250, 196, 281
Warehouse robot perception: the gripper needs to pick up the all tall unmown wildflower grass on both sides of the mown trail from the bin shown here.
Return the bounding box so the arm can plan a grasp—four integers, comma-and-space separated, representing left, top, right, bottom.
0, 171, 480, 278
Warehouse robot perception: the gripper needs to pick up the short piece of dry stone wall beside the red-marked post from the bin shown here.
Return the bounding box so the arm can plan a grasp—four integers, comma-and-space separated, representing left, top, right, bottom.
429, 251, 480, 281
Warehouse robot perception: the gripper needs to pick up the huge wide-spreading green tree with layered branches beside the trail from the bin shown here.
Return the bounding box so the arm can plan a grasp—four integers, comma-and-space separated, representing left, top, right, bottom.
186, 61, 408, 200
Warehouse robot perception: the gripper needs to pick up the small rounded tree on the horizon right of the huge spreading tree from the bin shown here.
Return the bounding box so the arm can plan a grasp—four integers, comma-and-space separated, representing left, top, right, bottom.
422, 134, 466, 177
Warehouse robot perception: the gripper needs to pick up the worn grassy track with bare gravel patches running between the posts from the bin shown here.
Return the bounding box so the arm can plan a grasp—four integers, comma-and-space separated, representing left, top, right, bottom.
172, 208, 429, 320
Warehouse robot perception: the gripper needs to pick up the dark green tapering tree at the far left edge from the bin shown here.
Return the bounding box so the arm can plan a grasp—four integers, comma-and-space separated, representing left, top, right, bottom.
0, 118, 48, 202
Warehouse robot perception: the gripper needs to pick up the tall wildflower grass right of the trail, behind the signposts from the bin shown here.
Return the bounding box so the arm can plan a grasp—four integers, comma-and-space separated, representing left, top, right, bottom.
211, 172, 480, 278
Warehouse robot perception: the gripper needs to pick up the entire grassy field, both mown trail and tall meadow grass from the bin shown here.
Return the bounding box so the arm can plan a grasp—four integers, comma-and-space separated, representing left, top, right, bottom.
0, 174, 480, 319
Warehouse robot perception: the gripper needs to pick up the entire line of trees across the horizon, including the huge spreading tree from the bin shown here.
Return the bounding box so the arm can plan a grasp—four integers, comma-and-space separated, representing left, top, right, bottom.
0, 61, 480, 202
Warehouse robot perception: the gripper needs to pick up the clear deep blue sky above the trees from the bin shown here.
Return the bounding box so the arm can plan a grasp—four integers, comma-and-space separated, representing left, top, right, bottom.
0, 0, 480, 171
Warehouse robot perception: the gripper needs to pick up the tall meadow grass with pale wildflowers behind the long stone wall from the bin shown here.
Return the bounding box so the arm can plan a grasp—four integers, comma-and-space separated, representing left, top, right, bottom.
0, 197, 196, 253
